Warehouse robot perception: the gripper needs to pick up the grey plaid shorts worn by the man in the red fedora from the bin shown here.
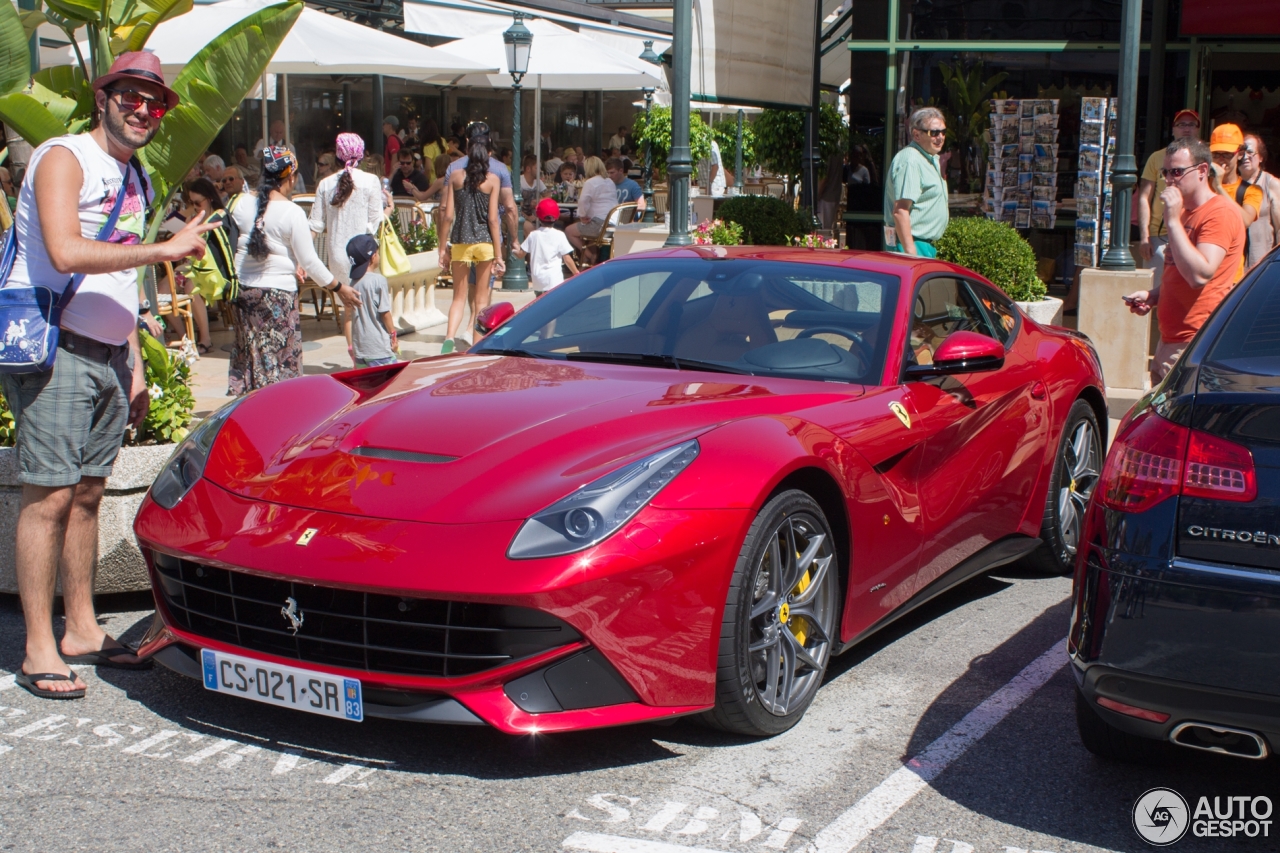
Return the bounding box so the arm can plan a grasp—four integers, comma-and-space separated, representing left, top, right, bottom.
0, 330, 133, 488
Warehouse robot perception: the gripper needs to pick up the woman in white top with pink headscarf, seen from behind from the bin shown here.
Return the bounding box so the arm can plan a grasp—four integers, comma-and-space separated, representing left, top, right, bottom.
311, 133, 383, 284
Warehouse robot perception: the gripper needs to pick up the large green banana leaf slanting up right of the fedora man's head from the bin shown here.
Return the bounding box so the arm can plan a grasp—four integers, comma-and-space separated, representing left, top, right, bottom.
139, 1, 302, 196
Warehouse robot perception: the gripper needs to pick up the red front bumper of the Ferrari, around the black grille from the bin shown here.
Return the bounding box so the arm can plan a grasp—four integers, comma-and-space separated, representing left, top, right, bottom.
134, 480, 750, 733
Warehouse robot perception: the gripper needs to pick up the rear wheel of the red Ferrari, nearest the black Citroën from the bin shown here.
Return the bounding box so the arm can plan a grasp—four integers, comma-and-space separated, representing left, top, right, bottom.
1028, 400, 1106, 575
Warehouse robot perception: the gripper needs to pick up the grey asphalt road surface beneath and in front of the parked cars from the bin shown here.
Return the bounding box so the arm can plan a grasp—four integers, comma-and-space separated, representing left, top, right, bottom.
0, 565, 1280, 853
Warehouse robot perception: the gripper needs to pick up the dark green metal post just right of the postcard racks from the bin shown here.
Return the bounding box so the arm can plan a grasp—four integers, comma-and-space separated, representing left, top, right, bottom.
1098, 0, 1155, 270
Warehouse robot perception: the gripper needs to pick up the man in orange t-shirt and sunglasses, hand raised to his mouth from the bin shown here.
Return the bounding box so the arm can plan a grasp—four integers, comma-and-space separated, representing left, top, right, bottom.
1124, 140, 1244, 384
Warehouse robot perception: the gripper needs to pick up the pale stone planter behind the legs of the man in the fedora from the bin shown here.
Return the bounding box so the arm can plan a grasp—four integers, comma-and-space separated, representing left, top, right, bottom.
0, 444, 173, 593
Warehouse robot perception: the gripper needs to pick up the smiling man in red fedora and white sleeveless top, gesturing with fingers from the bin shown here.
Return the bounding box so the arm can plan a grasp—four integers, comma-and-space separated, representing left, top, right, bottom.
3, 53, 216, 699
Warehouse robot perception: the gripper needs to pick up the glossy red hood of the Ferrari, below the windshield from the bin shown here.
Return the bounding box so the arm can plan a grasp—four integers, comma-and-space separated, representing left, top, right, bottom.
205, 353, 863, 524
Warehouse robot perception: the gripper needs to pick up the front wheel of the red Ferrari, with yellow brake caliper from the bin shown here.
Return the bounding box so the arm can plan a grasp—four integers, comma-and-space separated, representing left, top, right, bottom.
705, 491, 840, 736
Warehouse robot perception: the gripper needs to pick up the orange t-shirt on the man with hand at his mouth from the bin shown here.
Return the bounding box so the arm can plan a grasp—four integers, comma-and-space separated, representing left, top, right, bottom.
1156, 193, 1244, 342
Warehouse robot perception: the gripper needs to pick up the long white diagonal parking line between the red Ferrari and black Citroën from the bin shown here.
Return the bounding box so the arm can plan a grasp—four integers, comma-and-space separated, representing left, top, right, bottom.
808, 639, 1066, 853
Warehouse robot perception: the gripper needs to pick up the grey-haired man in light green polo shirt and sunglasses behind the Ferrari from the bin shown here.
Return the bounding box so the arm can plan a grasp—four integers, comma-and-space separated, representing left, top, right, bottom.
884, 106, 950, 257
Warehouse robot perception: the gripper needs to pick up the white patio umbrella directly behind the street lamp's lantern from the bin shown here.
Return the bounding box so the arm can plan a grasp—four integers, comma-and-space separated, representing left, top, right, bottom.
428, 18, 667, 92
